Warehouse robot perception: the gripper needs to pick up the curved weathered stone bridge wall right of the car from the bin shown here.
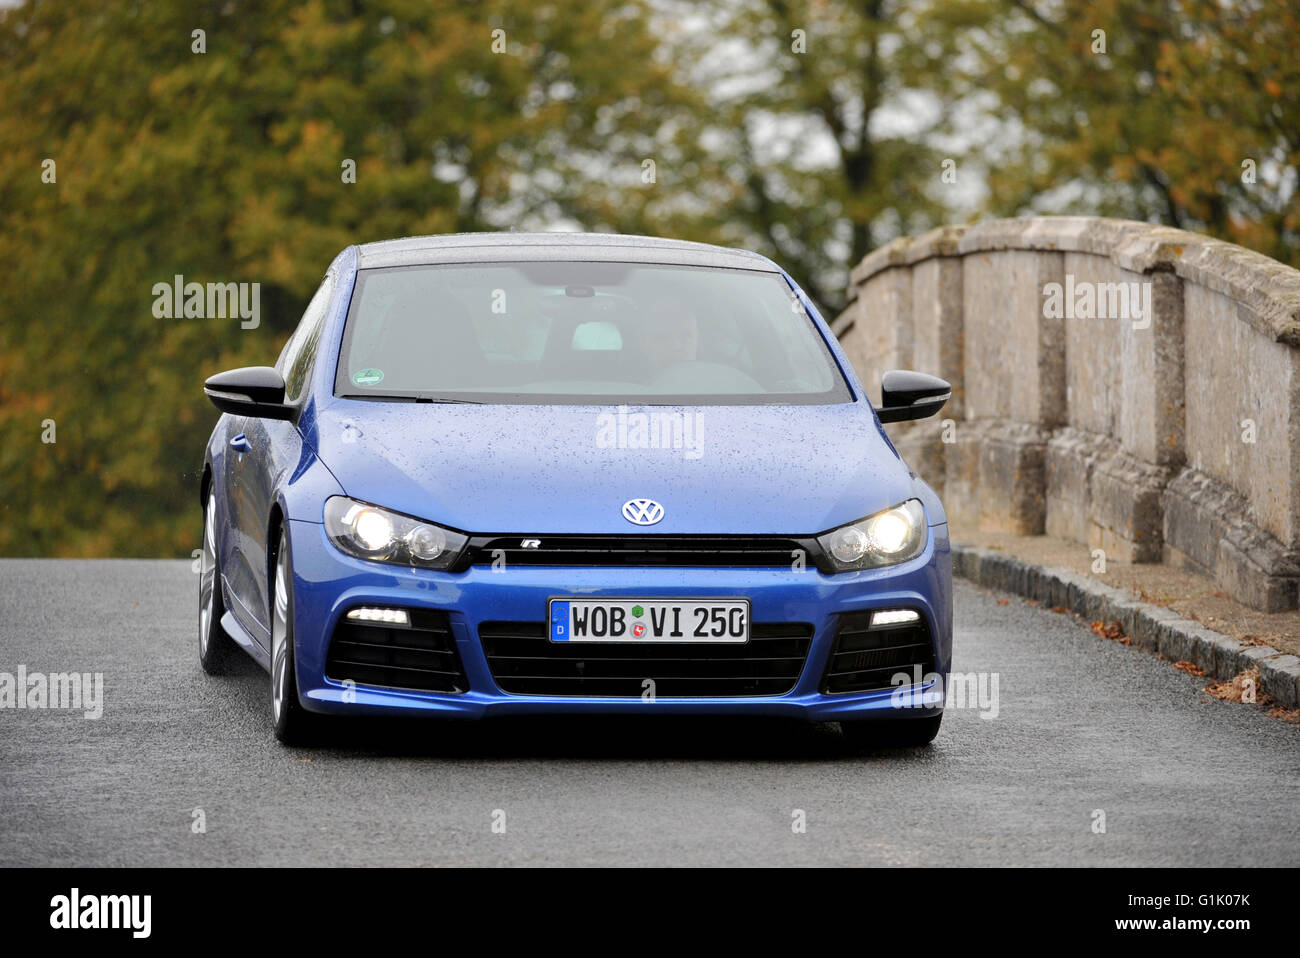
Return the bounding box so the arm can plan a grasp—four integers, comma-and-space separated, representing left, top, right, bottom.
833, 217, 1300, 611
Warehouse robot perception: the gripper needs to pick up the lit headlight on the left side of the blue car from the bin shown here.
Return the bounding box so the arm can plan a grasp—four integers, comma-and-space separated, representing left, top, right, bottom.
325, 495, 468, 569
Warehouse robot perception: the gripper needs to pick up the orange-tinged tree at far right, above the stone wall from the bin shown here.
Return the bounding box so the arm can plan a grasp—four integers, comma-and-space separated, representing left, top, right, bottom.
972, 0, 1300, 265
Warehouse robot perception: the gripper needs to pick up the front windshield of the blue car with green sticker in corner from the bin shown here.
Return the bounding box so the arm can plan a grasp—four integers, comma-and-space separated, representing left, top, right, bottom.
335, 263, 852, 404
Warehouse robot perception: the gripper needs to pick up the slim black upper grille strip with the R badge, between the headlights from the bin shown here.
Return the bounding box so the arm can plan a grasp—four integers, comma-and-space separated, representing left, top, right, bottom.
460, 536, 822, 569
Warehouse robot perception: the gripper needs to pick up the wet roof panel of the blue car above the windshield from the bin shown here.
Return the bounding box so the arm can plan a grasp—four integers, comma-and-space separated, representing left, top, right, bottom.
358, 233, 780, 273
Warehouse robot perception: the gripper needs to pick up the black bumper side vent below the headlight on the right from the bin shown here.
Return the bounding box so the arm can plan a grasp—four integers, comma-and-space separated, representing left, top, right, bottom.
822, 612, 935, 692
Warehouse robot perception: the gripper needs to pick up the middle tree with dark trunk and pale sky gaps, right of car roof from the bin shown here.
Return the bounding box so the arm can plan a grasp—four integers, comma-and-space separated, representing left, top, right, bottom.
689, 0, 979, 313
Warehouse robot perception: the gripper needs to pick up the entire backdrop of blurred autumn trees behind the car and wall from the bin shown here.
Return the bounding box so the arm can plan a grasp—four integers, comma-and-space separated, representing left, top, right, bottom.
0, 0, 1300, 555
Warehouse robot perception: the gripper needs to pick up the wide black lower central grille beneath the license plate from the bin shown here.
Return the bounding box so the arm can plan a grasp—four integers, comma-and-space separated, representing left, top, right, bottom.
478, 621, 813, 698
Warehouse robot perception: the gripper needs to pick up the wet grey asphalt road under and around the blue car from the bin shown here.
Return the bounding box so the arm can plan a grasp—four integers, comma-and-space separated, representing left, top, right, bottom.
0, 560, 1300, 866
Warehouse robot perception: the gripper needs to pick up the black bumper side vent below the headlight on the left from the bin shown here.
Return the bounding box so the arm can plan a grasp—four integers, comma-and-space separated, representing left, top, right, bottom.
325, 610, 469, 692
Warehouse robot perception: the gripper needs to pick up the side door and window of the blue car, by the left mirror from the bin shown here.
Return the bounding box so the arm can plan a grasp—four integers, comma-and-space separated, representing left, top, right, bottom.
234, 270, 334, 649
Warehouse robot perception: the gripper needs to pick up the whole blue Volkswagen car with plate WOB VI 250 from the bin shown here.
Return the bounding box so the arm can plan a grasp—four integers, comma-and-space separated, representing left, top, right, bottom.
199, 233, 952, 746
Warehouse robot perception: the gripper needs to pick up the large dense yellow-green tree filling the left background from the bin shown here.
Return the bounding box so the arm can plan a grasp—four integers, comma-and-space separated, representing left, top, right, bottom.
0, 0, 696, 555
